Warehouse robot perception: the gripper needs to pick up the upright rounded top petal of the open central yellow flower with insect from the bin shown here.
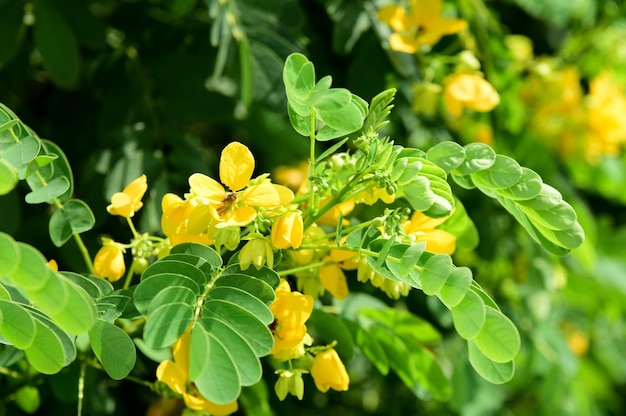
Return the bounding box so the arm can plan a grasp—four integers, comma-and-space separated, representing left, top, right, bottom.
220, 142, 254, 192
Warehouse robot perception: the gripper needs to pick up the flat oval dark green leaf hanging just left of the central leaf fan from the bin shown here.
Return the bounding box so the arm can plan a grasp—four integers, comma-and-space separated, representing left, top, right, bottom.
89, 319, 137, 380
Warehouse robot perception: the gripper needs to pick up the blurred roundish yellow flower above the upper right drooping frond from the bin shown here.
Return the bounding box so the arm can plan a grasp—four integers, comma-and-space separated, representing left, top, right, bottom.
443, 74, 500, 117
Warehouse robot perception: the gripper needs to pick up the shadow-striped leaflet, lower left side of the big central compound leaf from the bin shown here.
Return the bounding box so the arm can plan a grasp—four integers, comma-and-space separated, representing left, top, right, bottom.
143, 303, 194, 348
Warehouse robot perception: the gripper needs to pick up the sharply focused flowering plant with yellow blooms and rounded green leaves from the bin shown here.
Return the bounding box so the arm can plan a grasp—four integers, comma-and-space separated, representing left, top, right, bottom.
0, 47, 584, 415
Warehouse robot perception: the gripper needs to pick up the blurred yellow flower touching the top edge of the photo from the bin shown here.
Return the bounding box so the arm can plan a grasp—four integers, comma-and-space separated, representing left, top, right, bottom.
378, 0, 467, 53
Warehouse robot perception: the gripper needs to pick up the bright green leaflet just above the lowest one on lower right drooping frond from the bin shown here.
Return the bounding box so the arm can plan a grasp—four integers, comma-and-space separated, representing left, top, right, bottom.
473, 308, 521, 363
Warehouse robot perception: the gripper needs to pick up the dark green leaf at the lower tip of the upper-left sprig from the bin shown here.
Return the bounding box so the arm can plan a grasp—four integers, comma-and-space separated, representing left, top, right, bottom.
48, 199, 96, 247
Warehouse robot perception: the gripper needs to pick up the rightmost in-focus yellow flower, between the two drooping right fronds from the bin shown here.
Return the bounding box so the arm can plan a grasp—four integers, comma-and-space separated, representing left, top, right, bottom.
403, 211, 456, 254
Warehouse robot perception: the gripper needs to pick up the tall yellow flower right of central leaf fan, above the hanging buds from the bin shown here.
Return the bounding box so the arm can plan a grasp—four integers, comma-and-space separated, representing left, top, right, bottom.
270, 280, 315, 360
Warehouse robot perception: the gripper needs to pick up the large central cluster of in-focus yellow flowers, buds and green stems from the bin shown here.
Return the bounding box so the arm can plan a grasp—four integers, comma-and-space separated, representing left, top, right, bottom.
94, 135, 456, 414
